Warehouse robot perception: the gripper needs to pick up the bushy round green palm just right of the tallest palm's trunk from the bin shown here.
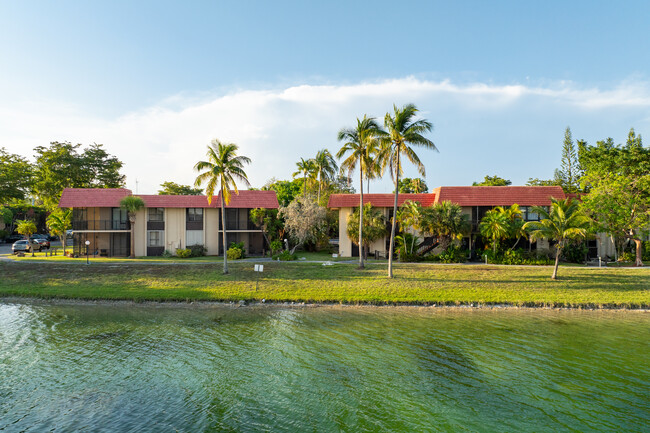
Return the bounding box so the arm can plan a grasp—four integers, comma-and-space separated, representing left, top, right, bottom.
420, 201, 471, 250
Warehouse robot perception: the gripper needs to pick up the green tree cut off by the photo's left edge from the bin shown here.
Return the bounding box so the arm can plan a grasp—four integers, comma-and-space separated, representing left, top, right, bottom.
0, 147, 34, 205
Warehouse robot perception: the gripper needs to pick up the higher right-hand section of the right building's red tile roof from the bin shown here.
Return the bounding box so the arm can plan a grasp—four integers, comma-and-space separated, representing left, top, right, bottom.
435, 186, 565, 206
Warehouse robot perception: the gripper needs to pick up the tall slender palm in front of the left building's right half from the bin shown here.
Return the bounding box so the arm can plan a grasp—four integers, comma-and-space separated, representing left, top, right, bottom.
194, 138, 251, 274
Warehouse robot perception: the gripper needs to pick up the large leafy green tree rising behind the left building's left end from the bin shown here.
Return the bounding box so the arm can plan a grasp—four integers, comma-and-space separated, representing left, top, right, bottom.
33, 141, 125, 209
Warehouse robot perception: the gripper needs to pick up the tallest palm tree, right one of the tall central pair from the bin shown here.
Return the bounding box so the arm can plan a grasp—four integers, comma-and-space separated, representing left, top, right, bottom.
381, 104, 438, 278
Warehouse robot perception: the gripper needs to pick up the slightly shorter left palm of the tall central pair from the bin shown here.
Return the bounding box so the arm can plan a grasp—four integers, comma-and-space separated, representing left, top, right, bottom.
336, 115, 384, 268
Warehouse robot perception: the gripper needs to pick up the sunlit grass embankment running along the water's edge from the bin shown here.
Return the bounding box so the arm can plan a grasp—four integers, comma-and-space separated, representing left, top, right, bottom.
0, 262, 650, 308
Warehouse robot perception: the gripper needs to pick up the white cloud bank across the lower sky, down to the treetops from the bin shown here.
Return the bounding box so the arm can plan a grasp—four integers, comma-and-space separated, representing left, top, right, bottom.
0, 77, 650, 193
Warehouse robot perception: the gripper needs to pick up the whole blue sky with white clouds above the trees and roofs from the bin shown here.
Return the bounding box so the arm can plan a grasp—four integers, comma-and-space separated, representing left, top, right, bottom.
0, 0, 650, 194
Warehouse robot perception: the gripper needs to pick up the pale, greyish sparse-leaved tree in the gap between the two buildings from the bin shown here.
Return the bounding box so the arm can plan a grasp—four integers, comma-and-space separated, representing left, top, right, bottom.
278, 195, 327, 254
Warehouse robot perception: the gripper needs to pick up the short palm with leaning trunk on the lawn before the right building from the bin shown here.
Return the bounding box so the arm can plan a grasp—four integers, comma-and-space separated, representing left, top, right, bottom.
524, 198, 590, 280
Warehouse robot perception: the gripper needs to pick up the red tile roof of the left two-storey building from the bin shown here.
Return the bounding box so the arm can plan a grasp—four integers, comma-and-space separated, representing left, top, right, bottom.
59, 188, 278, 209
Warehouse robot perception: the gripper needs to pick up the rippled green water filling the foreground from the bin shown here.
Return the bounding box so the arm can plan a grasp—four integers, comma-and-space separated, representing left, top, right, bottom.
0, 302, 650, 432
